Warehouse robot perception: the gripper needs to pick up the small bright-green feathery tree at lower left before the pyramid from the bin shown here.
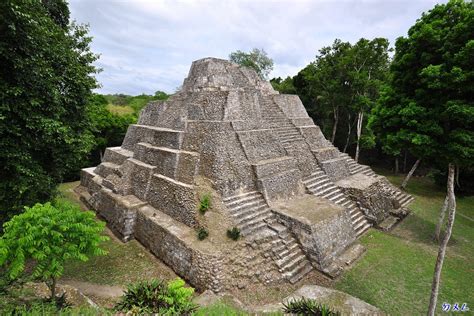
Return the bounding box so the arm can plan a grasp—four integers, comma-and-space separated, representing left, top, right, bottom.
0, 202, 108, 299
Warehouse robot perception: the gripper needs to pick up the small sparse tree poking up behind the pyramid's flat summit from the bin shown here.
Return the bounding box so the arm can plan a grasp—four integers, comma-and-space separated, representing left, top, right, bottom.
229, 48, 273, 79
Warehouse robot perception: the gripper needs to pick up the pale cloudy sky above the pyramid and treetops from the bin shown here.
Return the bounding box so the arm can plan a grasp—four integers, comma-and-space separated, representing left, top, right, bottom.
70, 0, 440, 95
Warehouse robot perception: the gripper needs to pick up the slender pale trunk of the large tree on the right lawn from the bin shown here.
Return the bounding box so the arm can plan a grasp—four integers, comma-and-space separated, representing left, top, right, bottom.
428, 163, 456, 316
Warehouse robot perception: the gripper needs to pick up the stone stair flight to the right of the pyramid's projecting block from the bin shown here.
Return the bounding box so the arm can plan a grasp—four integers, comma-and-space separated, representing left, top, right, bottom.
303, 169, 370, 237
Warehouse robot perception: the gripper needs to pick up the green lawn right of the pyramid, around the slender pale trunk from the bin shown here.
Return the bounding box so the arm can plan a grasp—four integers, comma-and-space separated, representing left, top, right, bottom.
336, 171, 474, 315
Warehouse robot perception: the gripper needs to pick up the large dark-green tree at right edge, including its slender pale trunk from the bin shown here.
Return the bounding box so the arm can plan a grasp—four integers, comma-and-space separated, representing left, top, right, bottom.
370, 0, 474, 315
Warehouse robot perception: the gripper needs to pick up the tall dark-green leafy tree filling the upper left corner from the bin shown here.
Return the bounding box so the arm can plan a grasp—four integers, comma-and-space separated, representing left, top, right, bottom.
0, 0, 97, 222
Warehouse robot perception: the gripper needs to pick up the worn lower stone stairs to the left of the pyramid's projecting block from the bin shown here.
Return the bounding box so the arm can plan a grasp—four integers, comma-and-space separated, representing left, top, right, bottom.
223, 191, 313, 283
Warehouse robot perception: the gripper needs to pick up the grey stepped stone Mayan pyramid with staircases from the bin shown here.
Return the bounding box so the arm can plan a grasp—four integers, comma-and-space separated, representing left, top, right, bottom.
78, 58, 412, 292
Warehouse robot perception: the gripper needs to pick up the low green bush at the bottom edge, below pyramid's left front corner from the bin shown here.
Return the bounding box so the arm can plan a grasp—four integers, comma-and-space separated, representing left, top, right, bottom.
115, 278, 197, 315
